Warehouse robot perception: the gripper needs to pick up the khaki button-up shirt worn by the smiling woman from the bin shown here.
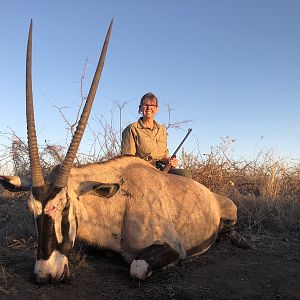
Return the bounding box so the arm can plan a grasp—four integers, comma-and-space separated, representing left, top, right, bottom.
121, 118, 169, 160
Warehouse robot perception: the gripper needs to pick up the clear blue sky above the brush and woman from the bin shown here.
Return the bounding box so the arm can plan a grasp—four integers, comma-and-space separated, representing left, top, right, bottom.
0, 0, 300, 163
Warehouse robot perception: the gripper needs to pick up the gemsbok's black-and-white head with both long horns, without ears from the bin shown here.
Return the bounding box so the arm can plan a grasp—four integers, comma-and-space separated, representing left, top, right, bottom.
26, 20, 113, 282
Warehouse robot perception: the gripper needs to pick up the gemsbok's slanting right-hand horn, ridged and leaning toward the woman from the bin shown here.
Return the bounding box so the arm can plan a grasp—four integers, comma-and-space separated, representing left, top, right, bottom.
54, 19, 113, 187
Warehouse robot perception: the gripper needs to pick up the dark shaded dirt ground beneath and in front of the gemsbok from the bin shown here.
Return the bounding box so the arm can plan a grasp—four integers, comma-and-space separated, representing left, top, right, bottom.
0, 193, 300, 299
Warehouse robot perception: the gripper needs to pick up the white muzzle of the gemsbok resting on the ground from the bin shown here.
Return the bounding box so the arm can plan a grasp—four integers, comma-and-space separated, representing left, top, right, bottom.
34, 250, 69, 280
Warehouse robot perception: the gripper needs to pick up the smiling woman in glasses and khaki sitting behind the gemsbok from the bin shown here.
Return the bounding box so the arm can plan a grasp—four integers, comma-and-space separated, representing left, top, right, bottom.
121, 93, 191, 177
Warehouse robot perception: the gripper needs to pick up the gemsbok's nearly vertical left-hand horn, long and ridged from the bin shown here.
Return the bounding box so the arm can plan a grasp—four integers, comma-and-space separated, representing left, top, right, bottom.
26, 20, 45, 187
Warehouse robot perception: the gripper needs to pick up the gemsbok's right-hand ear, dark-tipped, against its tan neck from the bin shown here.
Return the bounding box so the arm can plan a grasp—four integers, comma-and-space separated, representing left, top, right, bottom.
77, 181, 120, 198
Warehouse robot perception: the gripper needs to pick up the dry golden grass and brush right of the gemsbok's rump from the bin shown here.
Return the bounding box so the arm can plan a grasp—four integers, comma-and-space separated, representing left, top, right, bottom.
181, 138, 300, 234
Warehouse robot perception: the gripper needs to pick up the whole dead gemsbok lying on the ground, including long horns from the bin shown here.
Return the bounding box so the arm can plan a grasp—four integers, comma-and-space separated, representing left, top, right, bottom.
0, 22, 237, 283
